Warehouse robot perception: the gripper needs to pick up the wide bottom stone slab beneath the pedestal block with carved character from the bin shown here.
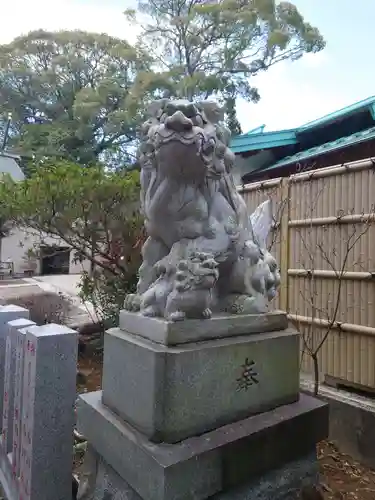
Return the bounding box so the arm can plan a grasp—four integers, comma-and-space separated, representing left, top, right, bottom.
77, 391, 328, 500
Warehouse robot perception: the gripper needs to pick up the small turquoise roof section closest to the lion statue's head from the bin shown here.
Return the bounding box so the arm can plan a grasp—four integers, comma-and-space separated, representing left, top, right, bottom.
230, 130, 298, 153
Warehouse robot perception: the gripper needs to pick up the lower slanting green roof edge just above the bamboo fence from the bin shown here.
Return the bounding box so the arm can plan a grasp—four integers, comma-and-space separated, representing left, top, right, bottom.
262, 127, 375, 172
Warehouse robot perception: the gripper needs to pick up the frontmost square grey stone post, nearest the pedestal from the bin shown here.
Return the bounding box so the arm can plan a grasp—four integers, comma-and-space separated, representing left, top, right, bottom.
20, 324, 78, 500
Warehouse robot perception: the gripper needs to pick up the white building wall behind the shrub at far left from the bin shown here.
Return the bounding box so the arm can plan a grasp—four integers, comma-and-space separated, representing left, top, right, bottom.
0, 228, 90, 274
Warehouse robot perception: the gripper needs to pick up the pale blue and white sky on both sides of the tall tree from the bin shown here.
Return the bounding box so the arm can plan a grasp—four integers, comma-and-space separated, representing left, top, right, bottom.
0, 0, 375, 132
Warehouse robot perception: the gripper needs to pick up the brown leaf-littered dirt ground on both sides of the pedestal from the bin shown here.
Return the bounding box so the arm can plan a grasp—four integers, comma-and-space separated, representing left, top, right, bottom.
78, 355, 375, 500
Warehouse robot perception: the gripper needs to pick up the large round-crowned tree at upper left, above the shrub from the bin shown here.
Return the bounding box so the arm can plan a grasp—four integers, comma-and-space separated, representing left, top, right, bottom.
0, 31, 149, 165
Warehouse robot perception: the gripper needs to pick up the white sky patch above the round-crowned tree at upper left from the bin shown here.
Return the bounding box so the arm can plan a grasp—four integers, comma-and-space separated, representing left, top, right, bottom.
0, 0, 136, 43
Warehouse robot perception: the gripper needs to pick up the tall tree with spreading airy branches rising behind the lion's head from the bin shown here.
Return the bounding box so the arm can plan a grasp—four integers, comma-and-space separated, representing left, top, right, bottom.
126, 0, 325, 129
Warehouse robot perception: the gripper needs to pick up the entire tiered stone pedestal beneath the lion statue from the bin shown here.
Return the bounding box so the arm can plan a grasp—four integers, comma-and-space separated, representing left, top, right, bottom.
78, 313, 328, 500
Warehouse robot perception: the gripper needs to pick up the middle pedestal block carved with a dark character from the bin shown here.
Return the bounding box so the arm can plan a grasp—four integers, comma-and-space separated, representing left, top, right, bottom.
102, 329, 299, 443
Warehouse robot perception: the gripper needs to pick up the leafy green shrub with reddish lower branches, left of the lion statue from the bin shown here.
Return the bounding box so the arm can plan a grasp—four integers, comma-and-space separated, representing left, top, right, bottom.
0, 161, 143, 322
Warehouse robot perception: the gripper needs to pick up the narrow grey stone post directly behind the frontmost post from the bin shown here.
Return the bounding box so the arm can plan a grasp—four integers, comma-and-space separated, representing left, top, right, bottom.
2, 318, 35, 453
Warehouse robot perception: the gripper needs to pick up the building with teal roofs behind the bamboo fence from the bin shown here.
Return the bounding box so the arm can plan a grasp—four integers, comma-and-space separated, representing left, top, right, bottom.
231, 96, 375, 184
